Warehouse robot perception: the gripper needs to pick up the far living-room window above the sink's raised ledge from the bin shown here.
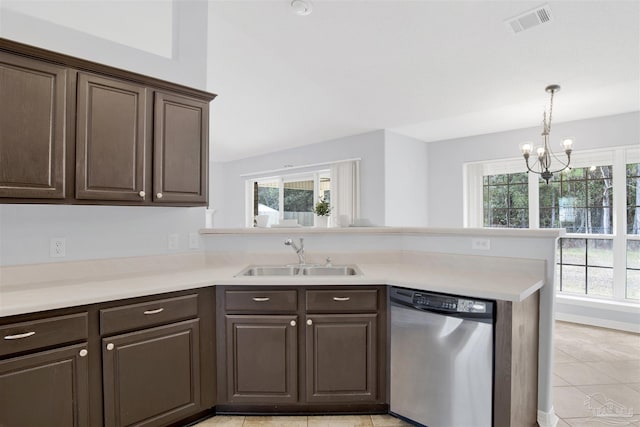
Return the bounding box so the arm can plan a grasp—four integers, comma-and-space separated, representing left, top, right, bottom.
247, 170, 331, 227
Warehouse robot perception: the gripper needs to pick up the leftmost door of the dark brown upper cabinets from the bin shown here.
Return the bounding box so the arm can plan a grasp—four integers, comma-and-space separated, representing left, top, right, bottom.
0, 52, 67, 199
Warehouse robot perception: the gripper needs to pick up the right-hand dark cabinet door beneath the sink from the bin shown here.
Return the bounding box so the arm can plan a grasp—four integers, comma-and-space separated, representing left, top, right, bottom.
306, 314, 378, 402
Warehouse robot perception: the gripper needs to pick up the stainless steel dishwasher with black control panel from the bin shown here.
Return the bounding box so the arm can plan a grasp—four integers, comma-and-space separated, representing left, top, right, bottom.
390, 286, 495, 427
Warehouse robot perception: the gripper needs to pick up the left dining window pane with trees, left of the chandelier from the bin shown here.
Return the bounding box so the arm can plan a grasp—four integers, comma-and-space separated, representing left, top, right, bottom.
482, 172, 529, 228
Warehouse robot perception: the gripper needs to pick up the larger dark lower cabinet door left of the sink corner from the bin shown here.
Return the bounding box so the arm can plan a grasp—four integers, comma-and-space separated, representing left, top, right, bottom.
102, 319, 201, 427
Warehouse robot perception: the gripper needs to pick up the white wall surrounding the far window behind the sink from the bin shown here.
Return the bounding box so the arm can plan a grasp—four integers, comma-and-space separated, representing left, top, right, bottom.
209, 130, 385, 228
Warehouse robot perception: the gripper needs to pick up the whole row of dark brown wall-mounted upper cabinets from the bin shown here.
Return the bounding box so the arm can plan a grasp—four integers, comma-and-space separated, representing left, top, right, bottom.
0, 38, 215, 206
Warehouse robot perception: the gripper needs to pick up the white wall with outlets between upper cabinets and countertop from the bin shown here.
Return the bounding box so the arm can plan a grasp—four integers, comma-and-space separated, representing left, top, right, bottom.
0, 205, 204, 266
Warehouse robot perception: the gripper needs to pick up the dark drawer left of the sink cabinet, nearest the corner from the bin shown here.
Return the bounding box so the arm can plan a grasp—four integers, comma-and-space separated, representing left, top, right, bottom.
100, 295, 198, 335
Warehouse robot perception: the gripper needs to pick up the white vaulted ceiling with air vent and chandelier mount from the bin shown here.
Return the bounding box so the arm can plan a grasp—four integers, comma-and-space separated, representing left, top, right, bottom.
208, 0, 640, 161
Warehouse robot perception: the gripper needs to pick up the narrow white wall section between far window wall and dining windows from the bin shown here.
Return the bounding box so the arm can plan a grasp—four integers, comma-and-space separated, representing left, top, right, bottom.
384, 130, 428, 227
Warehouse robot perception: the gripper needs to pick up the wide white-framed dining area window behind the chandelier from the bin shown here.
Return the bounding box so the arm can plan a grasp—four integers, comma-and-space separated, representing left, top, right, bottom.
465, 147, 640, 302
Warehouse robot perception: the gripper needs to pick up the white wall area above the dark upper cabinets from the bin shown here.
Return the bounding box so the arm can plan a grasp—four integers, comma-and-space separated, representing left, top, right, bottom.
0, 0, 208, 89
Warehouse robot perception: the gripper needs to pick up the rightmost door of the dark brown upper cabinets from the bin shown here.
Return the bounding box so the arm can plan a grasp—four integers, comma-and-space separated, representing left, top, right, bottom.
153, 92, 209, 205
